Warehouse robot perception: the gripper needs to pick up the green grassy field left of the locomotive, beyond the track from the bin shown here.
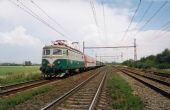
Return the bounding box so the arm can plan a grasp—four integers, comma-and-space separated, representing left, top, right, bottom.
0, 66, 41, 86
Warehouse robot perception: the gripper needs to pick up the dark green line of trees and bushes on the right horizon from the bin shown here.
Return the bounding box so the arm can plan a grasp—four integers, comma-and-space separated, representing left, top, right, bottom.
122, 49, 170, 69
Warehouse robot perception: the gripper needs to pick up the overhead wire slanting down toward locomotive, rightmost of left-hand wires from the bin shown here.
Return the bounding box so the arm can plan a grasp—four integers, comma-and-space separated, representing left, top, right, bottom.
30, 0, 71, 36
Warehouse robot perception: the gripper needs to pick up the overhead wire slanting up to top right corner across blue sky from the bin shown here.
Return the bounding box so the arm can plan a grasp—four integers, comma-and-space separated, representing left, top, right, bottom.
139, 1, 168, 30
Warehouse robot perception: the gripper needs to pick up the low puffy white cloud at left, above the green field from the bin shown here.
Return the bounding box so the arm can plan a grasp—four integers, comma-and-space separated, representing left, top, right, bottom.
0, 26, 42, 47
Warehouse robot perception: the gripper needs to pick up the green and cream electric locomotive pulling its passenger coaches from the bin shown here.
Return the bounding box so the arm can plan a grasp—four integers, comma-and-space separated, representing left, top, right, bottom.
40, 40, 104, 78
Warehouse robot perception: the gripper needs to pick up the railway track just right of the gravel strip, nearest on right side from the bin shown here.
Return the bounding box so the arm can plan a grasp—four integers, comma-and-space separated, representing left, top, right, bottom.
117, 68, 170, 99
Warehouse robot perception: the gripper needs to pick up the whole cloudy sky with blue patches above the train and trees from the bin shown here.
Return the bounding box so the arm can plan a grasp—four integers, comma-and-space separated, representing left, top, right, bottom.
0, 0, 170, 63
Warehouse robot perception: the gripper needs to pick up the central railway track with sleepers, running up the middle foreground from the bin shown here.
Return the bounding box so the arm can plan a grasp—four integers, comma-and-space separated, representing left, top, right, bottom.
41, 71, 106, 110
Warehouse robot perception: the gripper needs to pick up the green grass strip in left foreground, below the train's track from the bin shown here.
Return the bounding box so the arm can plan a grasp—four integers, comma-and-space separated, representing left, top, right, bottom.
0, 85, 53, 110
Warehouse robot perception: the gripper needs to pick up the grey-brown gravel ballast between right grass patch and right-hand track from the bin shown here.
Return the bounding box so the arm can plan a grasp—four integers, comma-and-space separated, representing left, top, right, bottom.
118, 72, 170, 110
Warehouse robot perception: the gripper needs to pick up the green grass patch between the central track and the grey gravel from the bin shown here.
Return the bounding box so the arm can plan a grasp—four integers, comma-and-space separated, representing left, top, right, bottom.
107, 73, 144, 110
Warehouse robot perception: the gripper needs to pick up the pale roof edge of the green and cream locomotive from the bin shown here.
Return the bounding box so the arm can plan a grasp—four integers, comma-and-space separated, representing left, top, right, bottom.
43, 45, 83, 54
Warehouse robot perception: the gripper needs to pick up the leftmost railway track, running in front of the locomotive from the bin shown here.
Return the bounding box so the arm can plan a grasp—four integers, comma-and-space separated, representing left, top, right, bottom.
0, 79, 56, 96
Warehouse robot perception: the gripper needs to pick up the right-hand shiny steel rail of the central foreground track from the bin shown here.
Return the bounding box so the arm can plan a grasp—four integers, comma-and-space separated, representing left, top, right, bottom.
88, 72, 106, 110
